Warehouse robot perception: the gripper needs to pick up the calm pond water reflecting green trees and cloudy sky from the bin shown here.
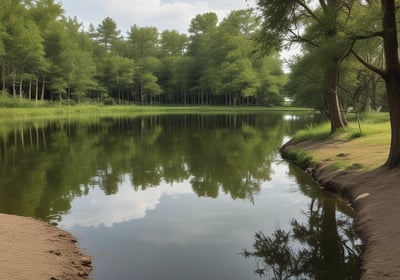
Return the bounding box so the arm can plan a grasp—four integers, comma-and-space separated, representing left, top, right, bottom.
0, 113, 361, 280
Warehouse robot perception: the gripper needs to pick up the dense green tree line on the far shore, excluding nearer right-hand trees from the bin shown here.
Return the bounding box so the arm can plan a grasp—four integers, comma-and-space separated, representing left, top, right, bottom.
0, 0, 286, 105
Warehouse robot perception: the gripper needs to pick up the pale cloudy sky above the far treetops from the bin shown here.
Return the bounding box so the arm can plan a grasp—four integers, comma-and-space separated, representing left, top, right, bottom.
58, 0, 255, 34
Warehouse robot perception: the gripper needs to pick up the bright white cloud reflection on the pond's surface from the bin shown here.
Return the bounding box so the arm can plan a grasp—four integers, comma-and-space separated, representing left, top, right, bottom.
60, 176, 193, 228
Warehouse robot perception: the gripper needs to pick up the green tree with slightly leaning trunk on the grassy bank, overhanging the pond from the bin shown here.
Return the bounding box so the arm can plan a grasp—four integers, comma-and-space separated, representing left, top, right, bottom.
257, 0, 353, 132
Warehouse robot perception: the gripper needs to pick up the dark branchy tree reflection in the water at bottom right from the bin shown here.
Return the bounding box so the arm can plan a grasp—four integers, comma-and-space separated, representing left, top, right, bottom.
243, 198, 362, 280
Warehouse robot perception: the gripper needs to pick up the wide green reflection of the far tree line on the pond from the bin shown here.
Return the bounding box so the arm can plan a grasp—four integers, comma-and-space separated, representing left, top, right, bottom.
0, 113, 318, 220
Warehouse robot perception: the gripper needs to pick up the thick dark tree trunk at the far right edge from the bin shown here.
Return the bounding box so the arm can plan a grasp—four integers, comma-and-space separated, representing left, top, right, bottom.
381, 0, 400, 168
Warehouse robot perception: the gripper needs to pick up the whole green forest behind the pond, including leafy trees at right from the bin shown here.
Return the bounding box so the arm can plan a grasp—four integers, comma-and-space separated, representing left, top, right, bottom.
0, 0, 394, 111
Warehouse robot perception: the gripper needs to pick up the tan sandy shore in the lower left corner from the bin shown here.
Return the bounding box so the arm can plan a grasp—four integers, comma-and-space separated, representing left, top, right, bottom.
0, 214, 92, 280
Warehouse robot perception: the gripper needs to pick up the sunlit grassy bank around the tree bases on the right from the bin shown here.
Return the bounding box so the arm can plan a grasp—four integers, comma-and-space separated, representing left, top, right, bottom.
285, 113, 390, 171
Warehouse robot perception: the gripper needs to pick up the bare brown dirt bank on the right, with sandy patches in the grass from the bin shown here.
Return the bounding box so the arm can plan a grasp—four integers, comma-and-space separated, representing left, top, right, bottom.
286, 141, 400, 280
